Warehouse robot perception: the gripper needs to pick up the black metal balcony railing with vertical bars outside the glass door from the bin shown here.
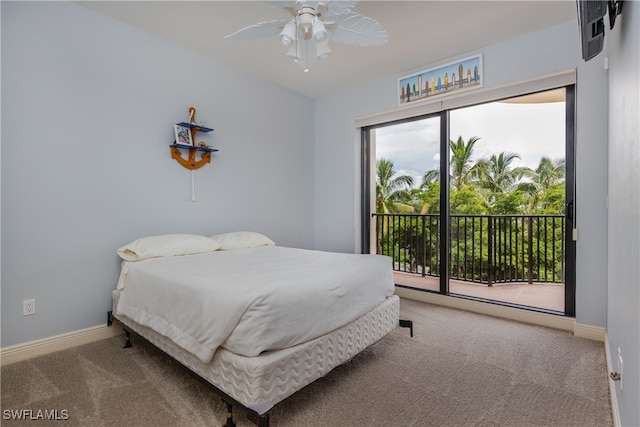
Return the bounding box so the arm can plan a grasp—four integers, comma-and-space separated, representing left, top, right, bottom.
372, 214, 565, 286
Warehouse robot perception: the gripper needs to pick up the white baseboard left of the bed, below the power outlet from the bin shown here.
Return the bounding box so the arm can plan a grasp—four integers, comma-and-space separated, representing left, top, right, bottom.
0, 325, 123, 366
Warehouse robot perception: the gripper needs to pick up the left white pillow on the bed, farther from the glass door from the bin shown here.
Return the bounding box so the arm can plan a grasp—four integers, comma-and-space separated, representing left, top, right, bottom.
117, 234, 220, 261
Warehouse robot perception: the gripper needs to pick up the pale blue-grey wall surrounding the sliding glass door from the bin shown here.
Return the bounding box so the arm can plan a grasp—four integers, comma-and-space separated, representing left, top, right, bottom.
315, 22, 607, 327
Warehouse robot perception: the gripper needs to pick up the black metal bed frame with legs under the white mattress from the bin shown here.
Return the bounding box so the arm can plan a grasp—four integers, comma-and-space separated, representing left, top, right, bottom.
107, 311, 413, 427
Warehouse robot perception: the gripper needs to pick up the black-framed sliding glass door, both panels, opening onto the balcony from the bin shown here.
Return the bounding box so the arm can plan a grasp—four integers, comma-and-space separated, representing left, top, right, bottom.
363, 86, 575, 315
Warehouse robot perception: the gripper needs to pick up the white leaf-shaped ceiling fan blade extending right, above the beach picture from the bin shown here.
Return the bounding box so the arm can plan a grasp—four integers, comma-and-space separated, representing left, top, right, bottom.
331, 12, 389, 46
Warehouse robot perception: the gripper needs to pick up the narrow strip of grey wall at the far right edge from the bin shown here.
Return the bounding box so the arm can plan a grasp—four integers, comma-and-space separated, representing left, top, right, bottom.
606, 2, 640, 426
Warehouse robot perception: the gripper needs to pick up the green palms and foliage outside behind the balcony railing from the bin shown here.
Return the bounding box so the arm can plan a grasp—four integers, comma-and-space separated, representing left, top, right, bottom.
376, 136, 565, 283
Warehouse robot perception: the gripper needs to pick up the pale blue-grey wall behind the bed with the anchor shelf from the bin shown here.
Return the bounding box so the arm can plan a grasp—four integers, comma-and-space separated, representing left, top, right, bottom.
1, 2, 315, 347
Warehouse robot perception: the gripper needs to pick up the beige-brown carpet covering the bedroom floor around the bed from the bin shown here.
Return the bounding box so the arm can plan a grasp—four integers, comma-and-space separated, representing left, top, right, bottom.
0, 300, 613, 427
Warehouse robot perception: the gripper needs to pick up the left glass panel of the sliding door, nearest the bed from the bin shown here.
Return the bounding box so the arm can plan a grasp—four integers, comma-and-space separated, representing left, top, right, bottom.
370, 115, 442, 291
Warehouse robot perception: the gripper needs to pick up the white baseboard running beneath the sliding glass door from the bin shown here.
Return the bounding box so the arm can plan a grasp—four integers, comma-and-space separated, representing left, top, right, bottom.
395, 287, 584, 341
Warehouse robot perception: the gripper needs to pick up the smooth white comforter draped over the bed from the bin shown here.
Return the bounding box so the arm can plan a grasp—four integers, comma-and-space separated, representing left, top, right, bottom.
116, 246, 394, 362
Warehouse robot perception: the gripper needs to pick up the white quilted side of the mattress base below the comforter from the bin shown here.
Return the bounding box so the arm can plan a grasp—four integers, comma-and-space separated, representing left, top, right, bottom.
113, 290, 400, 414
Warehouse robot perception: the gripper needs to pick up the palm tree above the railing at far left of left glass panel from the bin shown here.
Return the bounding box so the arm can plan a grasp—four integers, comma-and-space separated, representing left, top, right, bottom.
376, 159, 413, 213
